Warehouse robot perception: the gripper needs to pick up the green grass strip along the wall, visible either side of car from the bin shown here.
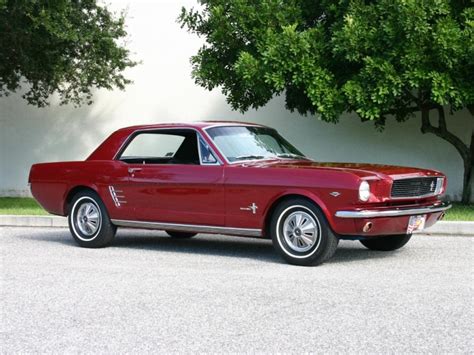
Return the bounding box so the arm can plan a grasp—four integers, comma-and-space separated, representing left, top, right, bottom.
0, 197, 474, 222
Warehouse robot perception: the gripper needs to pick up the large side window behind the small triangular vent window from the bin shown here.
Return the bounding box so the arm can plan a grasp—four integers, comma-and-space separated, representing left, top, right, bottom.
119, 130, 199, 164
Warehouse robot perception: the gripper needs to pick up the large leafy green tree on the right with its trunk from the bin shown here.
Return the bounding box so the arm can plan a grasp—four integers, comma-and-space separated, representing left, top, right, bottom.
179, 0, 474, 202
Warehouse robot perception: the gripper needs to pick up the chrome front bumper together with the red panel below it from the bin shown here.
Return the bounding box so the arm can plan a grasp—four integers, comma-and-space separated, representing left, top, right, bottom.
333, 201, 451, 237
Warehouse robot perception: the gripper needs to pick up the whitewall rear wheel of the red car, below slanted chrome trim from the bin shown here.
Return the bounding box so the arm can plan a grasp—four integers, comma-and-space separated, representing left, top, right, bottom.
68, 190, 117, 248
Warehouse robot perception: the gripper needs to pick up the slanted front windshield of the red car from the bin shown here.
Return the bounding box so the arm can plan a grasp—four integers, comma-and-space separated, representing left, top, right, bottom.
206, 126, 307, 163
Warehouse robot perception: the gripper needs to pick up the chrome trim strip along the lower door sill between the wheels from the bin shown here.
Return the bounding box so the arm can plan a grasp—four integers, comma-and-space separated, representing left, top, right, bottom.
110, 219, 262, 237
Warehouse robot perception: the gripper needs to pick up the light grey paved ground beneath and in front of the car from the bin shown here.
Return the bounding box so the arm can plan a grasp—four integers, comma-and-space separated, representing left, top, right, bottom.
0, 228, 474, 353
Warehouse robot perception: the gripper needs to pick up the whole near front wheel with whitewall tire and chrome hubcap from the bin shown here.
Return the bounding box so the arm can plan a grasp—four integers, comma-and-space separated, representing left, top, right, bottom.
270, 198, 339, 266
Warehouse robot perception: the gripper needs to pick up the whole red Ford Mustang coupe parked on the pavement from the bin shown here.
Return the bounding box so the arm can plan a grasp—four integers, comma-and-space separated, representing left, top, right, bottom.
29, 122, 451, 265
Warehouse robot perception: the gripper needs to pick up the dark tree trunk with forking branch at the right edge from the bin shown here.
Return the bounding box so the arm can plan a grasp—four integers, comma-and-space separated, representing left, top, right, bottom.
421, 106, 474, 203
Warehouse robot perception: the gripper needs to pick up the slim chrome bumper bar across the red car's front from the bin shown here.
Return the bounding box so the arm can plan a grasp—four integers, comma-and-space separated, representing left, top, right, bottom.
336, 202, 451, 218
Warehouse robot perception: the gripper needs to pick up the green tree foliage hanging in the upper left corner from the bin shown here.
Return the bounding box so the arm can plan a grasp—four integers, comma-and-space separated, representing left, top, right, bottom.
0, 0, 136, 107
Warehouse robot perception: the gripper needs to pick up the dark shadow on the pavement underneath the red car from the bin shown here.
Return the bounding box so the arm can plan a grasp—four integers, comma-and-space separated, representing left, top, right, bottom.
21, 230, 397, 264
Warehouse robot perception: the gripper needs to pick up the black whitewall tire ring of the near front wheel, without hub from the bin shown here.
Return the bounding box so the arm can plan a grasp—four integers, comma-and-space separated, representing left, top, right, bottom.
270, 199, 329, 265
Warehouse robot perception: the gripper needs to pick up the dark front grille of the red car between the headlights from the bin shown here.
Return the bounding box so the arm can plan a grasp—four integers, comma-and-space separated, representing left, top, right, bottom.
392, 177, 443, 198
